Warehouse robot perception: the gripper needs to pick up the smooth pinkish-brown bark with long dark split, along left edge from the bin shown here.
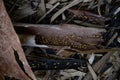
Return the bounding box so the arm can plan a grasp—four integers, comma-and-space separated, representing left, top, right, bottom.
0, 0, 36, 80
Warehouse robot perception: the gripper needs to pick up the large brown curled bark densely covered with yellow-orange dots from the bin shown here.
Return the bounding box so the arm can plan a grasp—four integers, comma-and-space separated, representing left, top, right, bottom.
16, 24, 105, 51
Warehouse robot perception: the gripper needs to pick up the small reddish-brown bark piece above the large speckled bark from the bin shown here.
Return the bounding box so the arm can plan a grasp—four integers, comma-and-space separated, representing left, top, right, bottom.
68, 9, 110, 25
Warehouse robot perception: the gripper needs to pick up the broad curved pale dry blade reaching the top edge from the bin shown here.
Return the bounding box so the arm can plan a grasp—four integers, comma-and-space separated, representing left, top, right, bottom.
51, 0, 83, 22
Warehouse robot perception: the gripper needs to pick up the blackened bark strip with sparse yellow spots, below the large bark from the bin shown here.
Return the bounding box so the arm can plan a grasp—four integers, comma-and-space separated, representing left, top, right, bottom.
29, 58, 87, 71
